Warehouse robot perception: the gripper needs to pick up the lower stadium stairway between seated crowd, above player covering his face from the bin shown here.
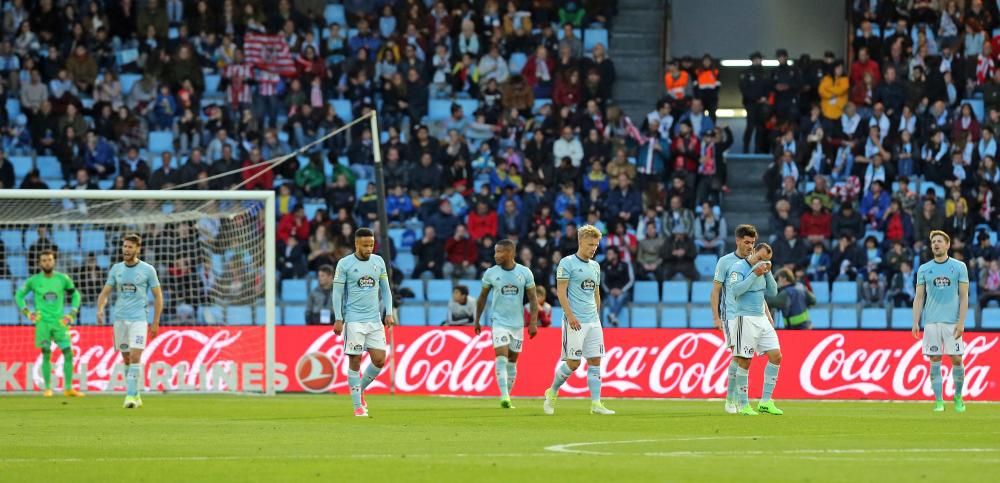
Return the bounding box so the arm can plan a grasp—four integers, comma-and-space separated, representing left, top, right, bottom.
722, 150, 771, 240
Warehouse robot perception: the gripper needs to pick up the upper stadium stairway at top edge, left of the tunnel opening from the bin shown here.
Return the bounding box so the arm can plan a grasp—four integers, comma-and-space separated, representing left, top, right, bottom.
609, 0, 665, 122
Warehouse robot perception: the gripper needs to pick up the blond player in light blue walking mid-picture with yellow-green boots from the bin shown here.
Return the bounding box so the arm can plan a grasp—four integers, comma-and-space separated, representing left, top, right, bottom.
542, 225, 615, 414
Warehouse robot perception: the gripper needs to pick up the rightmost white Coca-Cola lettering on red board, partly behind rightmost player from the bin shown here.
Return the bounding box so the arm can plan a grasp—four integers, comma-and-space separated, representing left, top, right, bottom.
799, 334, 998, 398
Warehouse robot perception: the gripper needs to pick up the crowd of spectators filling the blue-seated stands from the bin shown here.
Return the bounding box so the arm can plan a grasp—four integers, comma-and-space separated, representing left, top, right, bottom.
0, 0, 1000, 323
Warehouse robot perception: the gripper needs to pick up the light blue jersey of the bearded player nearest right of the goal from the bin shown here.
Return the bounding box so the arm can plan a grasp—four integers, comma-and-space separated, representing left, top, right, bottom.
332, 253, 392, 324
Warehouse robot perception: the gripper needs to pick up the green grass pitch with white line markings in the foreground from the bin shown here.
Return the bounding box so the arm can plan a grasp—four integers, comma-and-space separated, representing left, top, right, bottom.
0, 395, 1000, 483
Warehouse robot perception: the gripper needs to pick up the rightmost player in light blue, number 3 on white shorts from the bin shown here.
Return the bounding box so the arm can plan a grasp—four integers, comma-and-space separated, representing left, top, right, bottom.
913, 230, 969, 413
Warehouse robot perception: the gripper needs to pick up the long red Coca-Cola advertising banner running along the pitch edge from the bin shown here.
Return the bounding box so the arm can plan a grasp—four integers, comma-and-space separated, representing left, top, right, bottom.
0, 327, 1000, 401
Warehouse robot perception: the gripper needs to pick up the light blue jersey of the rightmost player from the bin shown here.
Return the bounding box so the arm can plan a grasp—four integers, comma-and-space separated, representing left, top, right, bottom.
917, 257, 969, 325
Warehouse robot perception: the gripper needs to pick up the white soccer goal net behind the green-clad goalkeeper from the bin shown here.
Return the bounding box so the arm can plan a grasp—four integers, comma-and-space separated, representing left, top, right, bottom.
0, 190, 275, 393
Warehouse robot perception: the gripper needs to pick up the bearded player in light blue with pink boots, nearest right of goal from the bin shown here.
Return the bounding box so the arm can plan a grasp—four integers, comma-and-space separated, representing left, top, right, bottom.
333, 228, 394, 417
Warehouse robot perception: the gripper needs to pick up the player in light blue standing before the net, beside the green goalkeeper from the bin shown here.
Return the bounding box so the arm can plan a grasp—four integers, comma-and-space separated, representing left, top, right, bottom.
97, 233, 163, 409
